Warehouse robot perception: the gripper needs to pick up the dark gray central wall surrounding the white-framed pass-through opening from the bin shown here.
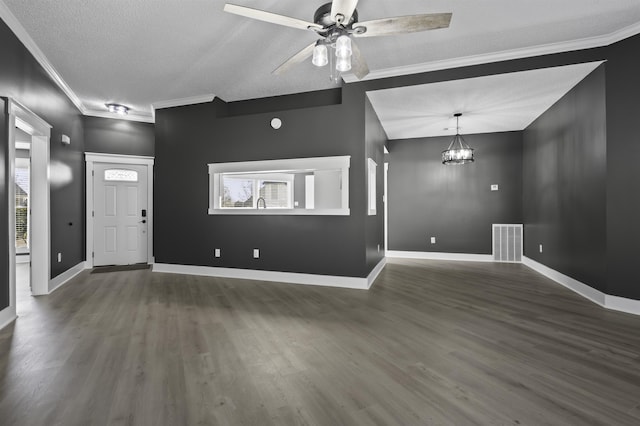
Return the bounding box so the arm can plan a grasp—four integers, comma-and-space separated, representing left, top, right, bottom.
154, 88, 372, 277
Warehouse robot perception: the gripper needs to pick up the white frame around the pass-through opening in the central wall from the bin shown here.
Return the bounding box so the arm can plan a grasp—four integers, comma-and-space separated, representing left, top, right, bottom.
207, 155, 351, 216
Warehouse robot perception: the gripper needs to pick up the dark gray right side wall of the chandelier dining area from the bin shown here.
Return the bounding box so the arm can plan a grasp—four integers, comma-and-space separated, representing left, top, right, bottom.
523, 65, 607, 291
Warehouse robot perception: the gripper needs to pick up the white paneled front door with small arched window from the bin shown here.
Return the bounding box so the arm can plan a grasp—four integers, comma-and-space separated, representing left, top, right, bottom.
93, 163, 148, 266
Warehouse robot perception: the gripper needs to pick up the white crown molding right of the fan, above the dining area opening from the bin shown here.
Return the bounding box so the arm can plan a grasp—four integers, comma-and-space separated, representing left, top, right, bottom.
343, 22, 640, 83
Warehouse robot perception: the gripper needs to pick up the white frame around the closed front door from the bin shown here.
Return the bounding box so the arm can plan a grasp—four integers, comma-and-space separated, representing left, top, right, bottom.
84, 152, 154, 268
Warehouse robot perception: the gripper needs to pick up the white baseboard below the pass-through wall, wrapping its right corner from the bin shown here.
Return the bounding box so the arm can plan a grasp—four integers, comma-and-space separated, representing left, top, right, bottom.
153, 261, 384, 290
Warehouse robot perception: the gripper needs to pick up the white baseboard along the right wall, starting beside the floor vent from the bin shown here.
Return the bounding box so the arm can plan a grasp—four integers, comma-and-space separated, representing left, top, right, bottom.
522, 256, 640, 315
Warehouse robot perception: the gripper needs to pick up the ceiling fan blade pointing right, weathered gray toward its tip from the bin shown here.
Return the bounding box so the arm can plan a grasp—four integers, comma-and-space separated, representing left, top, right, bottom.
353, 13, 452, 37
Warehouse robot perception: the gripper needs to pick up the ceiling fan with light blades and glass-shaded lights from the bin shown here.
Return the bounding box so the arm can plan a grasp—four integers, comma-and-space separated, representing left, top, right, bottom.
224, 0, 451, 80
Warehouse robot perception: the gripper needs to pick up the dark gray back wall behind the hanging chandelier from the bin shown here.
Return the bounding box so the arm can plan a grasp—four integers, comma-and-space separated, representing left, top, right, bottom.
388, 132, 522, 254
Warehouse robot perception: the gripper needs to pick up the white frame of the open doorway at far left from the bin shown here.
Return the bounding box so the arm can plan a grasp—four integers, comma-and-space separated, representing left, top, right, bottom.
7, 98, 52, 302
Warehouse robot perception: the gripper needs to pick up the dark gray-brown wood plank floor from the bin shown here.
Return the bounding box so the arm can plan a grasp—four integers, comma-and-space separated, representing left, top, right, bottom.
0, 260, 640, 426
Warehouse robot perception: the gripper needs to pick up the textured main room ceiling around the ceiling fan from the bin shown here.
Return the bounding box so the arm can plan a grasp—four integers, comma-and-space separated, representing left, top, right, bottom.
0, 0, 640, 123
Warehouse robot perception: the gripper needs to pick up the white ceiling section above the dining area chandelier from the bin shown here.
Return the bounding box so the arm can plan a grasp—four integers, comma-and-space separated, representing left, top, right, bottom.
367, 62, 601, 139
